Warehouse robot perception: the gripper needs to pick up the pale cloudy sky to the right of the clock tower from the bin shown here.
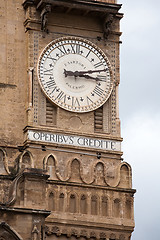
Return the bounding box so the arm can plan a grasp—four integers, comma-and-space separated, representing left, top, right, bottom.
118, 0, 160, 240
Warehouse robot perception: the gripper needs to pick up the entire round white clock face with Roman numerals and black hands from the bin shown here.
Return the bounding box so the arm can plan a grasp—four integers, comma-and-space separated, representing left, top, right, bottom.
37, 37, 113, 112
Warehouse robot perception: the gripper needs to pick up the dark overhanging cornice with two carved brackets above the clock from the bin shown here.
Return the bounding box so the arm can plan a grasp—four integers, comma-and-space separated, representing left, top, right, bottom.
23, 0, 123, 35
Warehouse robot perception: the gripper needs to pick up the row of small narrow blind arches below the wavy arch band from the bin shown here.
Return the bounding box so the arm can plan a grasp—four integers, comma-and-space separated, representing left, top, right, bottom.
47, 185, 133, 222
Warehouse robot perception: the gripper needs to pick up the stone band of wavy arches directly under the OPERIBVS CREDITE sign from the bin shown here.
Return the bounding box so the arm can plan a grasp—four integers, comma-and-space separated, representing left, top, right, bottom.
43, 154, 132, 188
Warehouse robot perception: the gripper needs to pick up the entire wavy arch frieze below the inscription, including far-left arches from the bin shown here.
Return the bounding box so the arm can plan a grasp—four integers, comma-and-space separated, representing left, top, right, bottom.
0, 149, 132, 188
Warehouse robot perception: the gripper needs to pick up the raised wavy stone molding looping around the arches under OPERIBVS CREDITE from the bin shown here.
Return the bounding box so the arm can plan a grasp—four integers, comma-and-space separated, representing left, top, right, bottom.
43, 154, 132, 189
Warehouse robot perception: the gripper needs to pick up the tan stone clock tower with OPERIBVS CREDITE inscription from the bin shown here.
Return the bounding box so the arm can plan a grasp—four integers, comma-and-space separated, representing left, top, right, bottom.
0, 0, 135, 240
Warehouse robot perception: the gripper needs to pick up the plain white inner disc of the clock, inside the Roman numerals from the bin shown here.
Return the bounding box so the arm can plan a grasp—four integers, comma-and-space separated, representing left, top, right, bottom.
53, 54, 96, 96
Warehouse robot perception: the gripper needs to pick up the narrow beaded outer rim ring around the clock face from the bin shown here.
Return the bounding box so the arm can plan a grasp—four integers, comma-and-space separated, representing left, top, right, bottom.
37, 36, 113, 113
